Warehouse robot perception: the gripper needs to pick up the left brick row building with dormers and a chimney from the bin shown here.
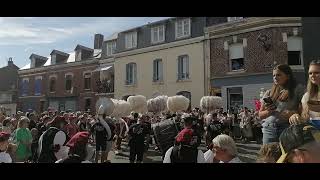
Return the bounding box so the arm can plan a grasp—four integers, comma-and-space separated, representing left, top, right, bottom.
18, 34, 113, 112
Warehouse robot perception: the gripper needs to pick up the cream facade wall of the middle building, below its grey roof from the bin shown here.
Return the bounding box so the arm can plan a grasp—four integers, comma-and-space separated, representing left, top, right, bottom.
114, 37, 204, 107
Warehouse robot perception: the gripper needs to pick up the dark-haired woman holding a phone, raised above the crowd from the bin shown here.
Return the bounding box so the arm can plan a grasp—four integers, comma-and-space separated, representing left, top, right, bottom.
259, 64, 304, 144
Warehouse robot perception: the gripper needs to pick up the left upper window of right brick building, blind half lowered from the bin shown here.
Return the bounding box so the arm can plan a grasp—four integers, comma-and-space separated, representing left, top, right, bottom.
229, 43, 244, 71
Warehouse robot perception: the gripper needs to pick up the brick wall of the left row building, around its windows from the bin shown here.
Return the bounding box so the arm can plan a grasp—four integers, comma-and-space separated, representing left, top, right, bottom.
19, 64, 100, 111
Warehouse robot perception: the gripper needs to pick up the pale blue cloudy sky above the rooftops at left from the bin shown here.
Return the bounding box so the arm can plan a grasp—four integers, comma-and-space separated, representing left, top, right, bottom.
0, 17, 167, 68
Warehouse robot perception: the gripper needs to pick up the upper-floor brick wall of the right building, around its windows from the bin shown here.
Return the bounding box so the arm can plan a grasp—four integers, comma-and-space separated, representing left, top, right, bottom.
210, 27, 301, 77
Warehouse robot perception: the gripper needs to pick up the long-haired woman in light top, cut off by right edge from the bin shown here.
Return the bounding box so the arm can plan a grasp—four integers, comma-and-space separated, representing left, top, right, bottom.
289, 60, 320, 129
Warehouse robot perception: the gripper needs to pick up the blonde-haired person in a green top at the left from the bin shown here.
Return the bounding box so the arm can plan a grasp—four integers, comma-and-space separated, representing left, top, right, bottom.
15, 117, 32, 162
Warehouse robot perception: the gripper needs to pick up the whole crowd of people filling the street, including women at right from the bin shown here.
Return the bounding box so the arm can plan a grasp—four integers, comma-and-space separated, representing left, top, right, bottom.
0, 61, 320, 163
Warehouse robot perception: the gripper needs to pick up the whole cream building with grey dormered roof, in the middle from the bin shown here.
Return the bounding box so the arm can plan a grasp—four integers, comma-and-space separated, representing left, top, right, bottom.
102, 17, 227, 108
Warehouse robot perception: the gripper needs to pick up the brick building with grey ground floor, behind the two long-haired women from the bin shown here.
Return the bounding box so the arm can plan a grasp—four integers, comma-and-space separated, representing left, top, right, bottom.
205, 17, 305, 109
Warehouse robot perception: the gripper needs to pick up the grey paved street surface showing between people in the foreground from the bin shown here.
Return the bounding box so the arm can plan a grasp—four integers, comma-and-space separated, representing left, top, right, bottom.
108, 141, 261, 163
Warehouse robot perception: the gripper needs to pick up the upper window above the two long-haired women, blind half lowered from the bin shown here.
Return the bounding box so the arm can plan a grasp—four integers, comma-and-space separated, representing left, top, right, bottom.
287, 37, 303, 65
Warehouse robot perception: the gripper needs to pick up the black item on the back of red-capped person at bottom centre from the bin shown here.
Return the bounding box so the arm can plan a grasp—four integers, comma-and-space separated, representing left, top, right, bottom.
170, 144, 198, 163
